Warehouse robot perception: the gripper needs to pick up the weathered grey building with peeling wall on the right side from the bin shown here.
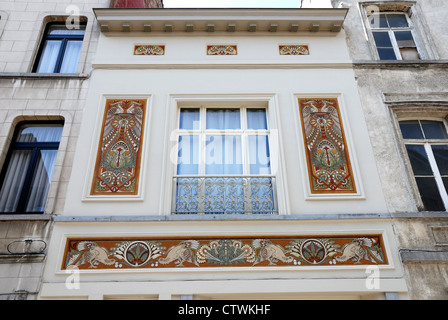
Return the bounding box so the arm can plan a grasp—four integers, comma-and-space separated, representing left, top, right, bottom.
333, 0, 448, 299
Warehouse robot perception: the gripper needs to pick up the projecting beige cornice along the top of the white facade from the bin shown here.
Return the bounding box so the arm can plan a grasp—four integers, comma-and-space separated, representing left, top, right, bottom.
93, 8, 348, 34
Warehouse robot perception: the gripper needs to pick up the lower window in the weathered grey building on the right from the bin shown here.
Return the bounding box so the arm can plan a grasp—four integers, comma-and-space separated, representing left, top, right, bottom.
400, 120, 448, 211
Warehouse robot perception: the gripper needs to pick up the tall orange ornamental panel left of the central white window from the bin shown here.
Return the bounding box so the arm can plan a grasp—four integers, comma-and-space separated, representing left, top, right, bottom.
90, 99, 146, 195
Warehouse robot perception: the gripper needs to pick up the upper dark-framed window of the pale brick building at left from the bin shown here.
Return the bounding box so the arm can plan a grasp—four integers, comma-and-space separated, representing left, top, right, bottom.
34, 24, 85, 73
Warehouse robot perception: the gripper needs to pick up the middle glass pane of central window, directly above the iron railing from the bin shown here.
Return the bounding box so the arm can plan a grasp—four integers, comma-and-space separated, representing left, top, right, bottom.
205, 136, 243, 174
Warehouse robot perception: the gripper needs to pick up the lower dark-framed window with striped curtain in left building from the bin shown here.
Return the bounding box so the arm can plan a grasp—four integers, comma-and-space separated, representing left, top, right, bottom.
0, 122, 63, 213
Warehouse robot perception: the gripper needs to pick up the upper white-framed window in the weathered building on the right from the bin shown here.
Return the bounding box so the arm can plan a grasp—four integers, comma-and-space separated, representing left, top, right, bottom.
368, 12, 420, 60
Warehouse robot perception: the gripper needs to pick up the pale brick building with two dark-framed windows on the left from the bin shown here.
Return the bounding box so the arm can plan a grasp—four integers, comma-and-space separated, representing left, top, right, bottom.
0, 0, 110, 300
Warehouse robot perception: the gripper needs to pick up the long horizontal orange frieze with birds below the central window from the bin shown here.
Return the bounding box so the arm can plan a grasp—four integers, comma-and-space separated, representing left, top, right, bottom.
62, 235, 388, 270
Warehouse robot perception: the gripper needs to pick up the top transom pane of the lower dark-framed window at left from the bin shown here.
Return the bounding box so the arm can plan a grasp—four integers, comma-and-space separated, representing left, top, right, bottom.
16, 124, 63, 142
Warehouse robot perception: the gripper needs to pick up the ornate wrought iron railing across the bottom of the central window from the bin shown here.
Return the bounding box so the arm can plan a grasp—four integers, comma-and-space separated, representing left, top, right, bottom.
172, 176, 278, 214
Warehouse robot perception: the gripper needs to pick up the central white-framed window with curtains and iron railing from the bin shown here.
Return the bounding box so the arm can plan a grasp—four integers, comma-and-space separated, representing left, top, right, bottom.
173, 107, 276, 214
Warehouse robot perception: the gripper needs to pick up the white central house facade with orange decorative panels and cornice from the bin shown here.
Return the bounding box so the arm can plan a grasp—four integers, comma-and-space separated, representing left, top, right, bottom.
39, 2, 408, 299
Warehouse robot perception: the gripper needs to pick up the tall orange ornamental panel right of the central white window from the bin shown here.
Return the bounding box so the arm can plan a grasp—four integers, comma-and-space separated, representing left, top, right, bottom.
299, 98, 356, 194
